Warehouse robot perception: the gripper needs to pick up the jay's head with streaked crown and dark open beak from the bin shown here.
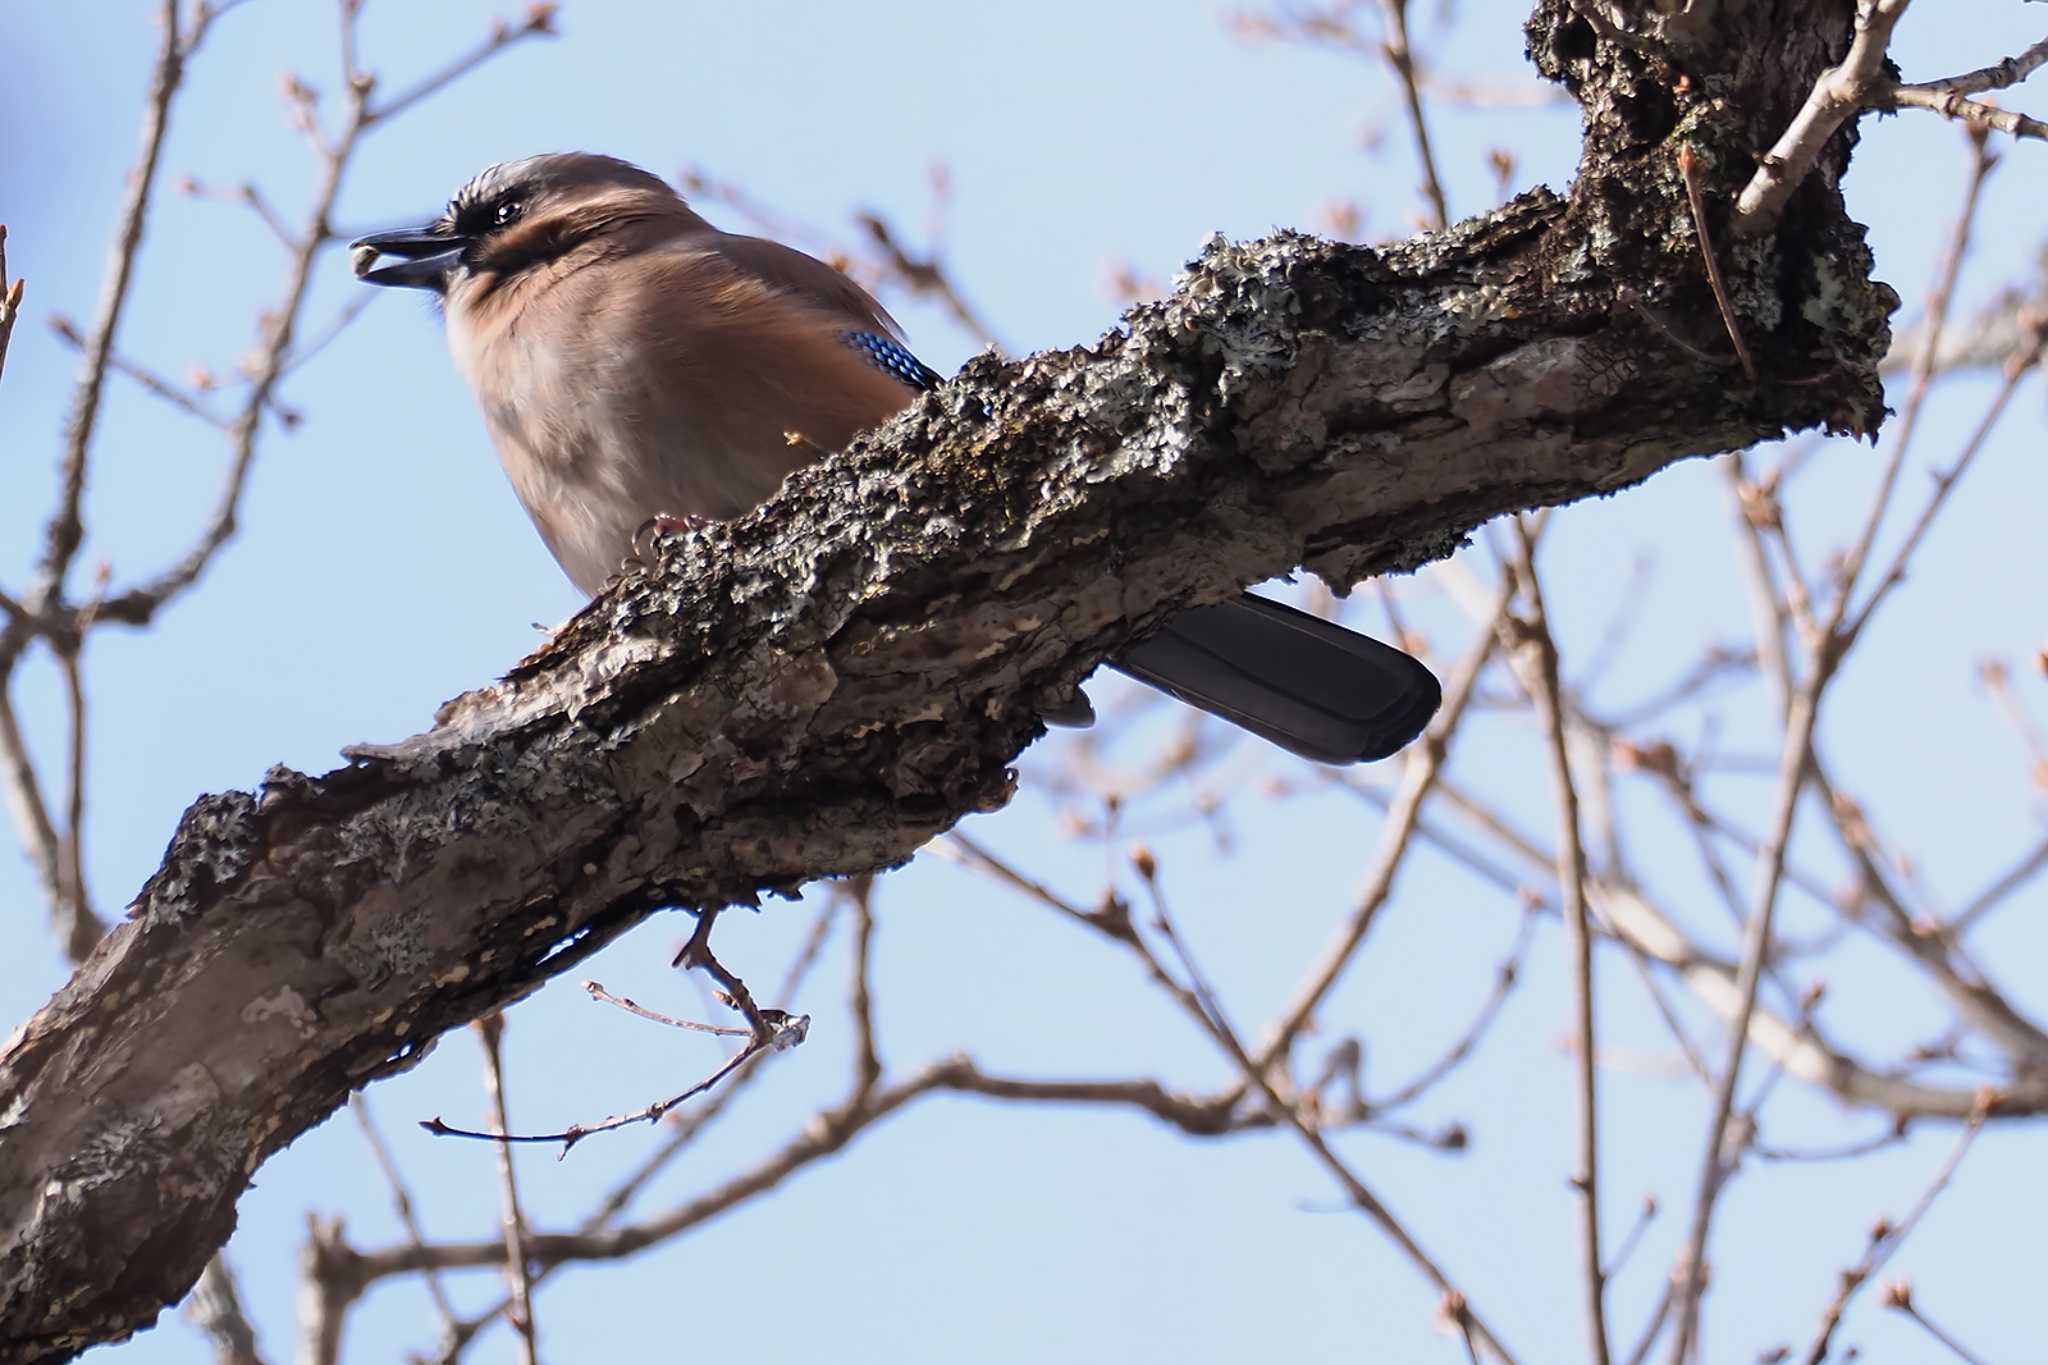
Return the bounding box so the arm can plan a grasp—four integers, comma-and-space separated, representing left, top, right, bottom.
348, 151, 675, 303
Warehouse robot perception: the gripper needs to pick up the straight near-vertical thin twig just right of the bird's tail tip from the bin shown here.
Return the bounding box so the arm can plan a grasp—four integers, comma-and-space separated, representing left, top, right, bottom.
1513, 518, 1610, 1365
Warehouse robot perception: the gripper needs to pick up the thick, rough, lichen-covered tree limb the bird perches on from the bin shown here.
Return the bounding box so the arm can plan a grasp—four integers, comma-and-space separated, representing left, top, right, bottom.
0, 0, 1896, 1361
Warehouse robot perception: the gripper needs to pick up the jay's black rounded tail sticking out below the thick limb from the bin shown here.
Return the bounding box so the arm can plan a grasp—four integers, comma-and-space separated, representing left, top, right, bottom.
1112, 593, 1444, 763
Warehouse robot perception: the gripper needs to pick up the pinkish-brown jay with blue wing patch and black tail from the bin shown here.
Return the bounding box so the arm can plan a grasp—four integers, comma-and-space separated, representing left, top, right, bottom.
350, 151, 1442, 763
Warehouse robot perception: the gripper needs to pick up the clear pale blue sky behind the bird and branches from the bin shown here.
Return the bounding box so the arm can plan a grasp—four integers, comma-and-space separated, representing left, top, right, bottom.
0, 0, 2048, 1365
